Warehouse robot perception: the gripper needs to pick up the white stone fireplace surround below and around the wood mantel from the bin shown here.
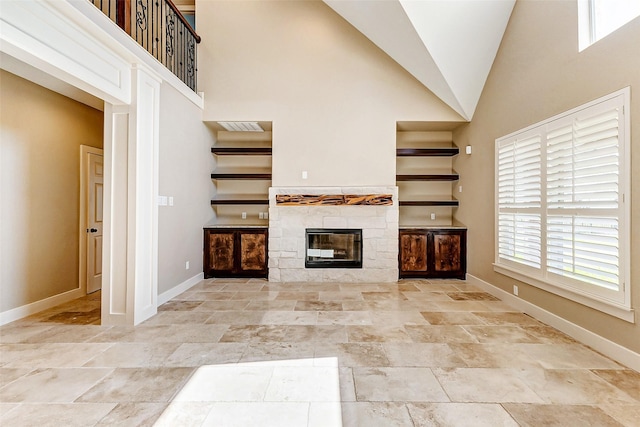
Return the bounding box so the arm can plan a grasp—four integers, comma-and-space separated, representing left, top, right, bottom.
268, 186, 399, 283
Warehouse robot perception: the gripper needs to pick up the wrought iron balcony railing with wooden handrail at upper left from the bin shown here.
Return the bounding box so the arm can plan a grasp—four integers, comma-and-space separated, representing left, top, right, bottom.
89, 0, 200, 92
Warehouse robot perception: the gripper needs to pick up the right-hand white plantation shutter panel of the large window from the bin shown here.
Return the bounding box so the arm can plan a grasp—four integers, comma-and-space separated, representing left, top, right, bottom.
547, 103, 620, 290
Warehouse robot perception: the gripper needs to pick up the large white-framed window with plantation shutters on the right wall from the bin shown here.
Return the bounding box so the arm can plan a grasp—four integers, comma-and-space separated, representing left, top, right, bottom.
495, 88, 632, 319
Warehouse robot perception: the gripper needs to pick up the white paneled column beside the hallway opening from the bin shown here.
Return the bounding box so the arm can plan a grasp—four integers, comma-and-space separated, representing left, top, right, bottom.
102, 66, 160, 325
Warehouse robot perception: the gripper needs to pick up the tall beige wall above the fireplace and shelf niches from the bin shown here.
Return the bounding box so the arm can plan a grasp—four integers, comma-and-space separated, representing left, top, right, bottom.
196, 0, 462, 186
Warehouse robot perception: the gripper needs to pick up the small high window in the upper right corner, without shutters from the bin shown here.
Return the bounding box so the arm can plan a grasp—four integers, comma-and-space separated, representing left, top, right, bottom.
578, 0, 640, 51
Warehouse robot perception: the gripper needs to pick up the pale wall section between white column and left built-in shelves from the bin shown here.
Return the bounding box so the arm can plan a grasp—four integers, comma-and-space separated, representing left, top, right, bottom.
158, 83, 213, 294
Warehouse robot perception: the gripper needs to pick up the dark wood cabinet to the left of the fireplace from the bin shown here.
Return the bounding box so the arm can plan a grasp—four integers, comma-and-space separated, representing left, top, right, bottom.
204, 228, 268, 278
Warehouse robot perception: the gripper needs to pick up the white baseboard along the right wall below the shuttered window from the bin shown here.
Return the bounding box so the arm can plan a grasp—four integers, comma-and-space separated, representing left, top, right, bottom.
467, 274, 640, 371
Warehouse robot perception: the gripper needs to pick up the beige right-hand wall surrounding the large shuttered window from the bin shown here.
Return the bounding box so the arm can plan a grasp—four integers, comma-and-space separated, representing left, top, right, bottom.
454, 0, 640, 352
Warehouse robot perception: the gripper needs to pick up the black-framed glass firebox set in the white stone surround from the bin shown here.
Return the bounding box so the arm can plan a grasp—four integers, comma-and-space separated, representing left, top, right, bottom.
304, 228, 362, 268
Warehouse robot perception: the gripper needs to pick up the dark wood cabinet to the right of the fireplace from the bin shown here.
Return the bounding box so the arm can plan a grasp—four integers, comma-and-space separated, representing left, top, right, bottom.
398, 228, 467, 279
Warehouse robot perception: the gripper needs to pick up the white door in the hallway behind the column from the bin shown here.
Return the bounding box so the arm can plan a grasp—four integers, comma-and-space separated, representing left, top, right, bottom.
85, 153, 104, 293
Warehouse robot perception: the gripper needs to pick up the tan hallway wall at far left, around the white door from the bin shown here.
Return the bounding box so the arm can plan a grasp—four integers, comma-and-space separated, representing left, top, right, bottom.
0, 71, 103, 312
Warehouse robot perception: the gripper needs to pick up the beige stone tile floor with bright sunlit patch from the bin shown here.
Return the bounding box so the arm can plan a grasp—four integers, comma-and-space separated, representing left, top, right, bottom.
0, 279, 640, 427
